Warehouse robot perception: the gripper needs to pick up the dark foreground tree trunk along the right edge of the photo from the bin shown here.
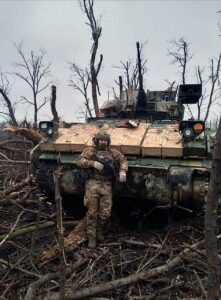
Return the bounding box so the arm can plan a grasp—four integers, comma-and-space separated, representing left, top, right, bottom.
205, 119, 221, 300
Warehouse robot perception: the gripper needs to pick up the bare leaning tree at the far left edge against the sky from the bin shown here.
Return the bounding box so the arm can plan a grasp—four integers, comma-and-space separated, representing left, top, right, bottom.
0, 72, 18, 126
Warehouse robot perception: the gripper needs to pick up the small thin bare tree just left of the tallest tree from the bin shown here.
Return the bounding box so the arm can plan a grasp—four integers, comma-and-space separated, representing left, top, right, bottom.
69, 63, 92, 118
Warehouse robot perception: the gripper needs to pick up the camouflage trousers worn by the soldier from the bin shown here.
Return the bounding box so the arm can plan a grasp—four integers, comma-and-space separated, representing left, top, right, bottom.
84, 179, 112, 238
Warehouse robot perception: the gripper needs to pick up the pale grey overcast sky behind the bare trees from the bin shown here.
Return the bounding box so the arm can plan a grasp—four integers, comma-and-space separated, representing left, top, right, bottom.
0, 0, 221, 121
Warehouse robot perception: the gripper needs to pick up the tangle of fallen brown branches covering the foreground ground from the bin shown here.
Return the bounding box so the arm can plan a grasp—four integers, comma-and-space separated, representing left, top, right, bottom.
0, 186, 221, 300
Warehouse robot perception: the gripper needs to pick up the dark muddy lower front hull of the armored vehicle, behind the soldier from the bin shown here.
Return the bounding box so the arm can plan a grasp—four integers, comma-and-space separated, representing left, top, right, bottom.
37, 157, 210, 205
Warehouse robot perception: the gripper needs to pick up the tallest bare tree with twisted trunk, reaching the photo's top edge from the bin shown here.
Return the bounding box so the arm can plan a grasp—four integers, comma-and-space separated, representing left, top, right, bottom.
80, 0, 103, 117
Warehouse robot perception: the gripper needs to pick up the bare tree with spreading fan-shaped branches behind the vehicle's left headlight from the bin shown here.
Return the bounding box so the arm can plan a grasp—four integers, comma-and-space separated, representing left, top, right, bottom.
14, 43, 51, 129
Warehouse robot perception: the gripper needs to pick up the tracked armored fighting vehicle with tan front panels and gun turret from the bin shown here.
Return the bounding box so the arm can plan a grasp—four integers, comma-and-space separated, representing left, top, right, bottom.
32, 44, 213, 211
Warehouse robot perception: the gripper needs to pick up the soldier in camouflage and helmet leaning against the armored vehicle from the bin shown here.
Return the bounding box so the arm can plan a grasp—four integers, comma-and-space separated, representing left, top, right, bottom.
76, 130, 128, 248
